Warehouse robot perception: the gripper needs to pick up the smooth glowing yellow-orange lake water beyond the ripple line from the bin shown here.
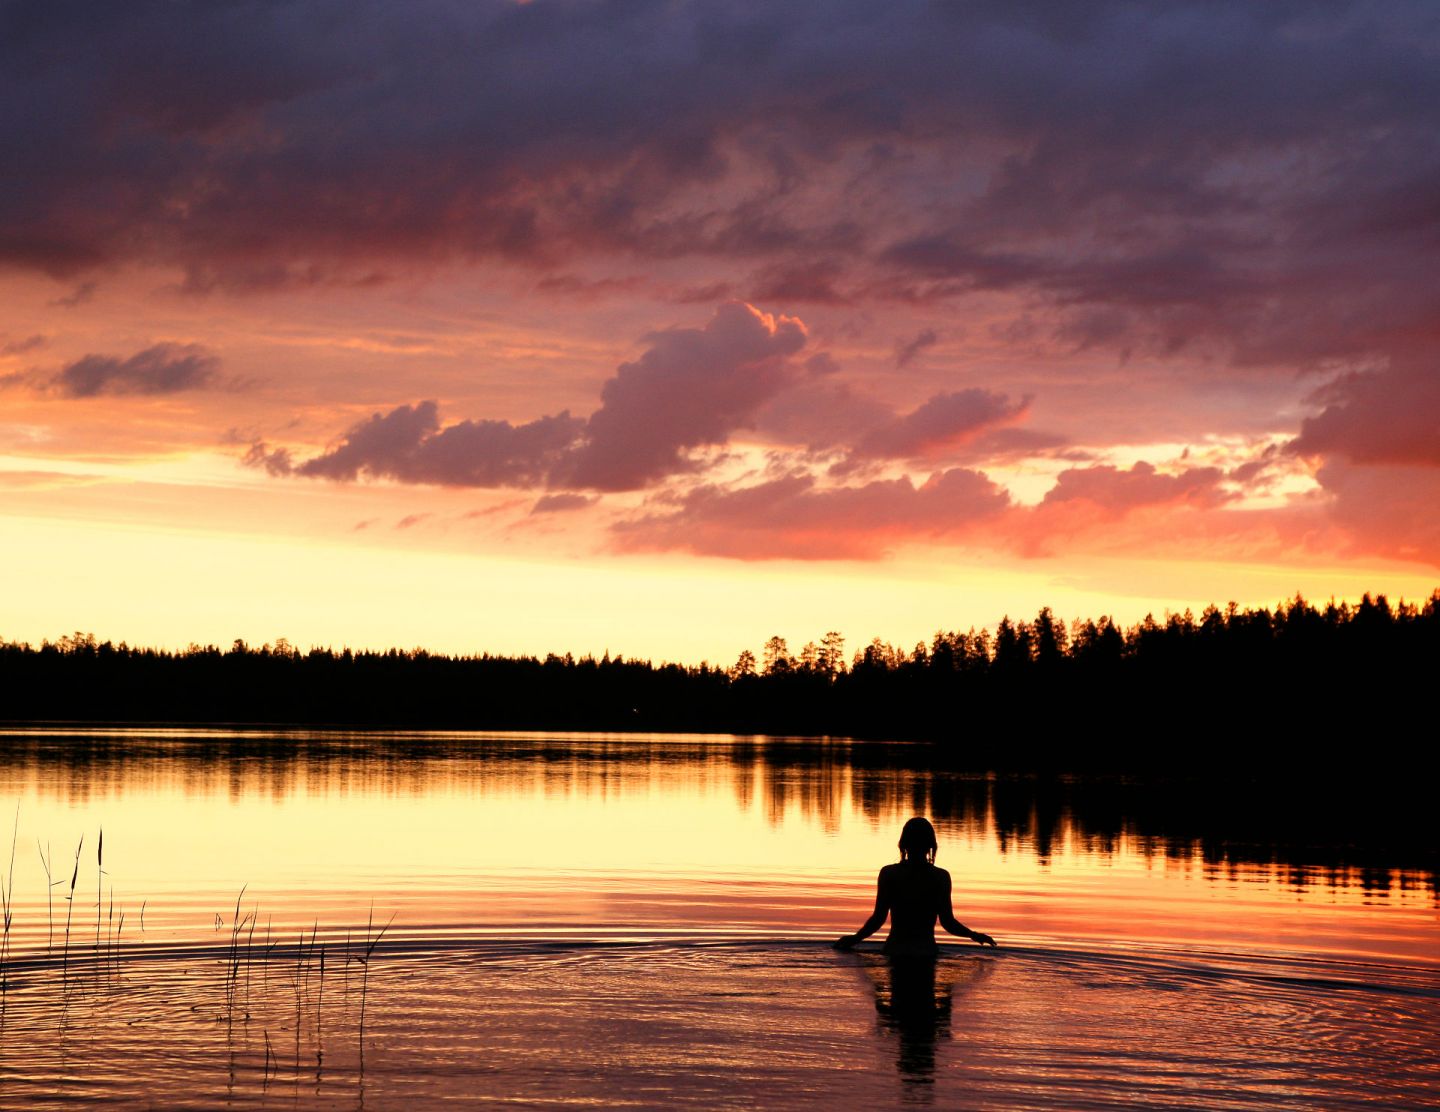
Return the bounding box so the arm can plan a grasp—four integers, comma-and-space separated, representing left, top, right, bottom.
0, 730, 1440, 964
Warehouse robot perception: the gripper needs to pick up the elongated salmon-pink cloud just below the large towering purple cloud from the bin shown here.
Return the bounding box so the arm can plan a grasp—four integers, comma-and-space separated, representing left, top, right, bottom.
613, 468, 1009, 560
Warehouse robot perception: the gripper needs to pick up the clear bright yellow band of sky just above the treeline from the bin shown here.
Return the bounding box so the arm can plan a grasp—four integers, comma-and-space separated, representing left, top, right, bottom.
0, 507, 1434, 664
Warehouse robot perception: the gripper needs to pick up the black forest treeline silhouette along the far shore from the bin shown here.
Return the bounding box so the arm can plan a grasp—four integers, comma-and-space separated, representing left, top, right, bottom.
0, 589, 1440, 768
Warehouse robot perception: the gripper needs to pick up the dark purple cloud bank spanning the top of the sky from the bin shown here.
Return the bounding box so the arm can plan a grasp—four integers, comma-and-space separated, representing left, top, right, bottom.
0, 0, 1440, 374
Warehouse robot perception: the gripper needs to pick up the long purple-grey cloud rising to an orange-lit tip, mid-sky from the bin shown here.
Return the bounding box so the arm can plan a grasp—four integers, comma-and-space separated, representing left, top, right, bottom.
263, 302, 829, 491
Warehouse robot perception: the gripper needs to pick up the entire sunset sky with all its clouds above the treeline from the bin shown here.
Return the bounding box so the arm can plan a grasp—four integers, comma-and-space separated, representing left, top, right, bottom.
0, 0, 1440, 663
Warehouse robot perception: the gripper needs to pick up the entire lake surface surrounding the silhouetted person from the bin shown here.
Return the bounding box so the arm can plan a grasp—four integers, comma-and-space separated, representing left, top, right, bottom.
0, 730, 1440, 1108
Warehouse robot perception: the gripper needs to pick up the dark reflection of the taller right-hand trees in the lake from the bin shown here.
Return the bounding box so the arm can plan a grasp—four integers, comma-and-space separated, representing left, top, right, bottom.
733, 742, 1440, 897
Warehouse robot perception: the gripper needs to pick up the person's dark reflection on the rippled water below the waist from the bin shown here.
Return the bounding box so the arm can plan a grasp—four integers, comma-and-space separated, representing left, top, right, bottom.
848, 954, 994, 1103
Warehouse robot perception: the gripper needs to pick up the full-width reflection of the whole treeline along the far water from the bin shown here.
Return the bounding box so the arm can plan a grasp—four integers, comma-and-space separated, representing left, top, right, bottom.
0, 730, 1440, 897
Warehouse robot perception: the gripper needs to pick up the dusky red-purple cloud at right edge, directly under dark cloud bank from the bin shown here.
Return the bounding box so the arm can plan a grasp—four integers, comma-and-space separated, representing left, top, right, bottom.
1289, 356, 1440, 467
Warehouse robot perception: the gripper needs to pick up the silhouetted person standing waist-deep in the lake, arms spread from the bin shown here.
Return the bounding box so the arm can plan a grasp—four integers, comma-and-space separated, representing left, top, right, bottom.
835, 818, 995, 958
